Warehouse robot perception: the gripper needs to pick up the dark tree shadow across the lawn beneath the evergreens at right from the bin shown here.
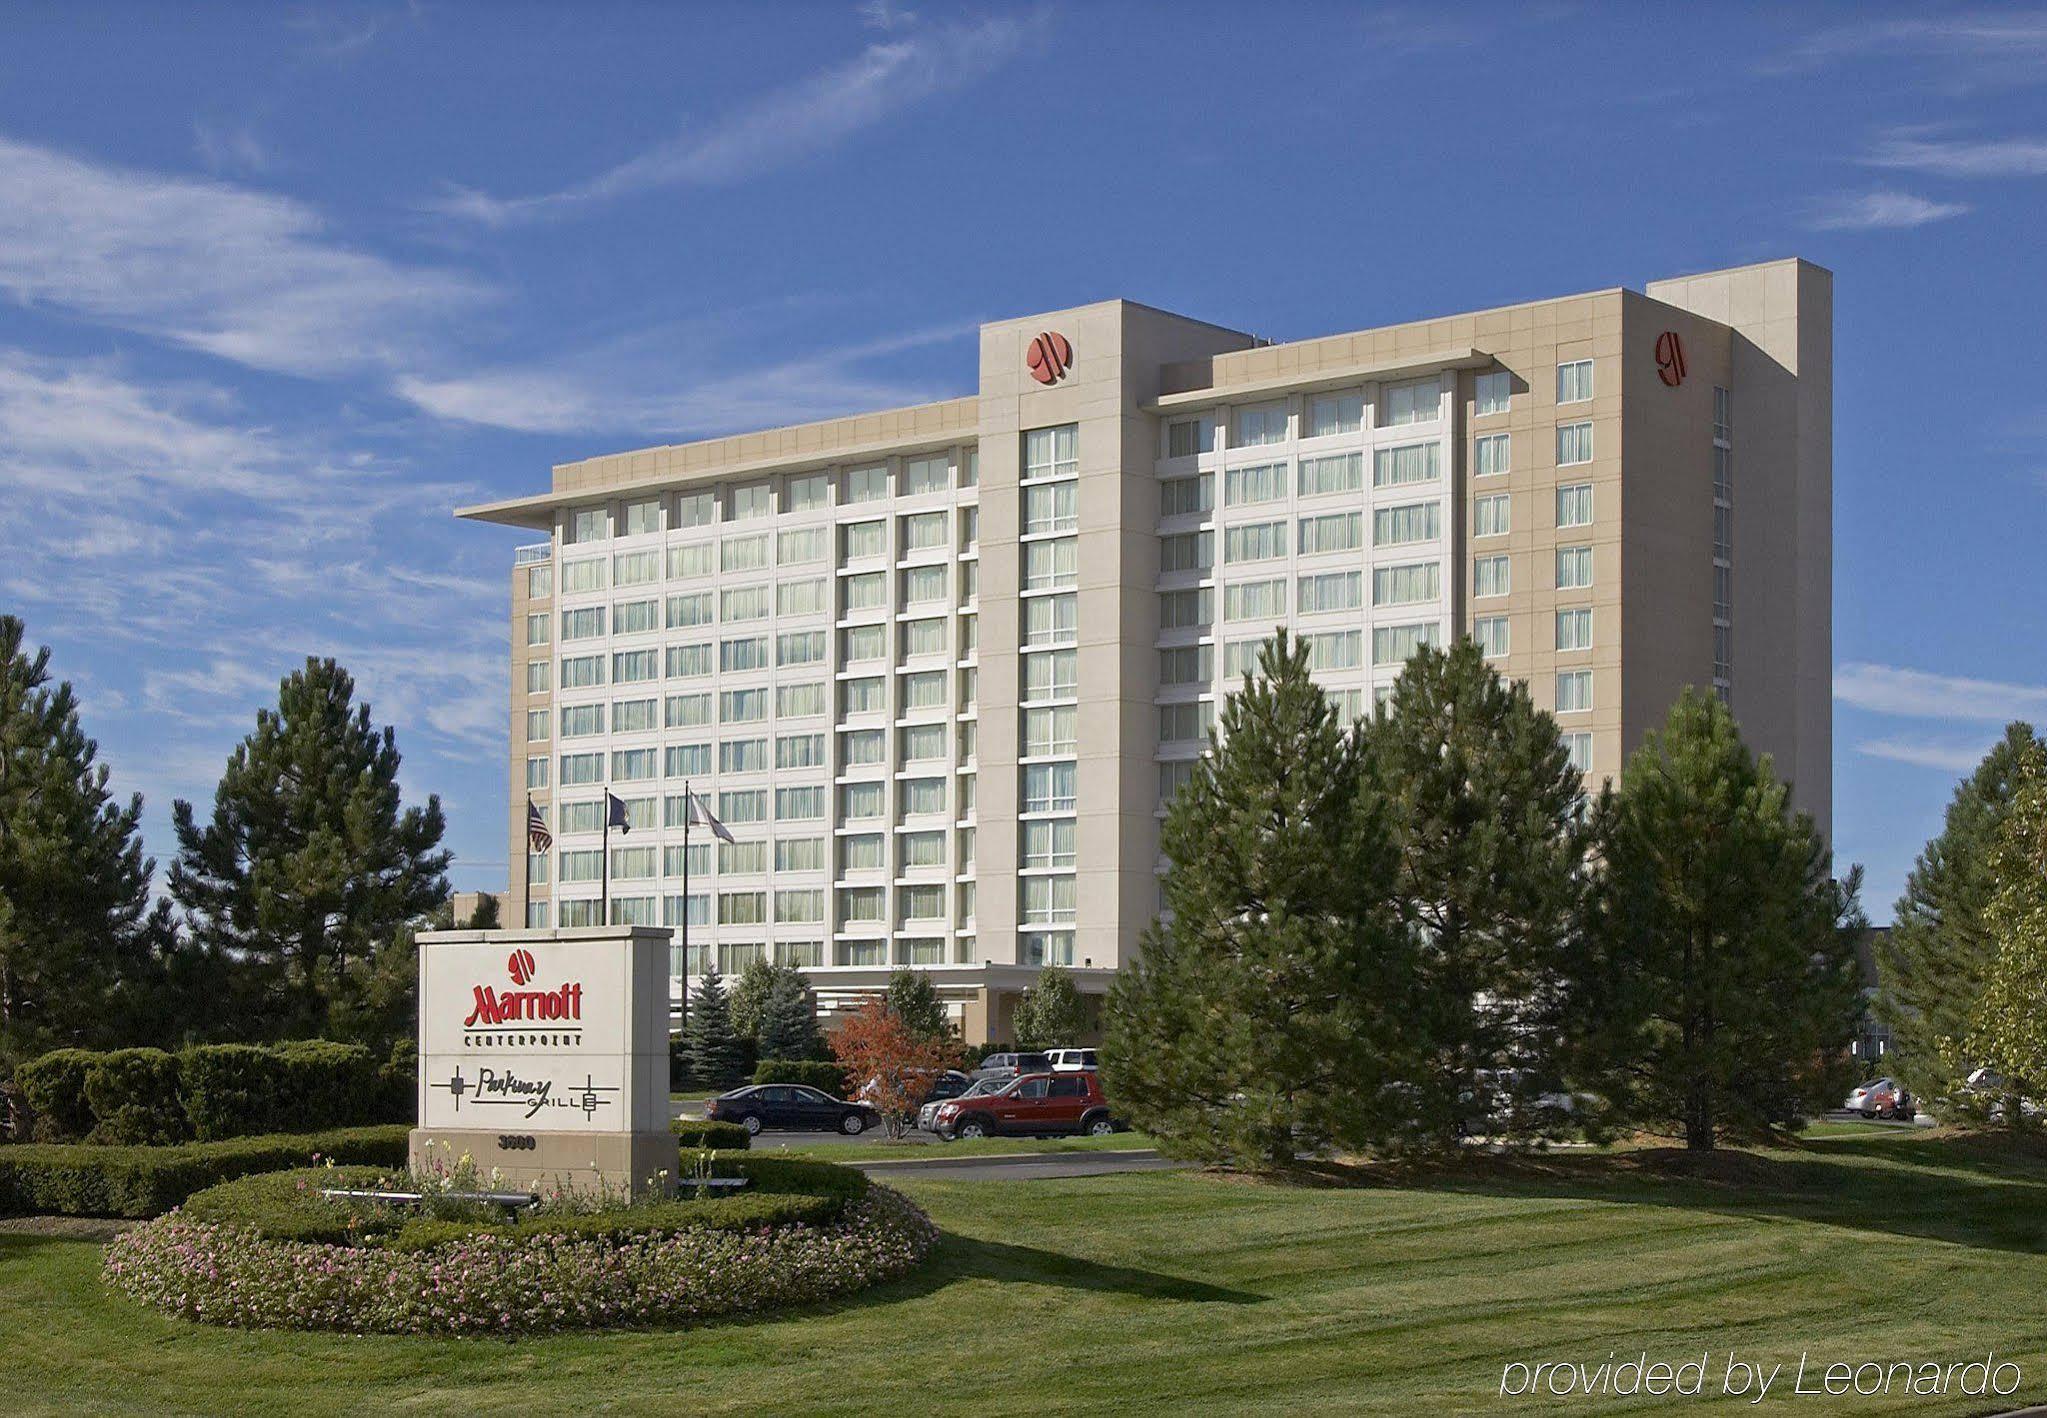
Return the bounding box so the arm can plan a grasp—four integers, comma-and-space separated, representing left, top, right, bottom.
1302, 1138, 2047, 1254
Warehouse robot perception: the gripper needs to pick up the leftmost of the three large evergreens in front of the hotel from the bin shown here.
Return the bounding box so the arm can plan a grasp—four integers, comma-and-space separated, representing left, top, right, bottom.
1101, 630, 1406, 1168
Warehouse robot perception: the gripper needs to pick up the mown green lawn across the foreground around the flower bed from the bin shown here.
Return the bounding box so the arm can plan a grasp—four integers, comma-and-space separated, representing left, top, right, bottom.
0, 1132, 2047, 1416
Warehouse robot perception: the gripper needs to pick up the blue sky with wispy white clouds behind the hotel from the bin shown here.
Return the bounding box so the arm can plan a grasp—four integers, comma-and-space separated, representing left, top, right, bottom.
0, 2, 2047, 921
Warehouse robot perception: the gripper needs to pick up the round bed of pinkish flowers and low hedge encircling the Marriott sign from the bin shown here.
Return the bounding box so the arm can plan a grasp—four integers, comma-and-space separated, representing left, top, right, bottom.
104, 1156, 935, 1334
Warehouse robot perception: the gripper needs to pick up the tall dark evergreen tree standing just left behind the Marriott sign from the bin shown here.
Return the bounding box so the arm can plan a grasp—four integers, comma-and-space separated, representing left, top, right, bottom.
170, 659, 448, 1048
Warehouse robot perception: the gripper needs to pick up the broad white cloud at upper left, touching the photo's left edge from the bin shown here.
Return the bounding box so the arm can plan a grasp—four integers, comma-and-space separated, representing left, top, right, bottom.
0, 137, 491, 374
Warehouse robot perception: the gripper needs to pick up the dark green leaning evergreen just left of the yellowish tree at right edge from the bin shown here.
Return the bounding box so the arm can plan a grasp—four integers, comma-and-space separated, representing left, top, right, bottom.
1877, 724, 2041, 1099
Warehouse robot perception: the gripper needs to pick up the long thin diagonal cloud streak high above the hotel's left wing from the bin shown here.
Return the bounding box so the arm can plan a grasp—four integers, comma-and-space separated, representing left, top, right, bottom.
432, 12, 1042, 225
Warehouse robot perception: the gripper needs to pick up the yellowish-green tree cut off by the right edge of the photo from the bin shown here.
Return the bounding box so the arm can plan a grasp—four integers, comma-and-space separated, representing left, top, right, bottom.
1945, 741, 2047, 1127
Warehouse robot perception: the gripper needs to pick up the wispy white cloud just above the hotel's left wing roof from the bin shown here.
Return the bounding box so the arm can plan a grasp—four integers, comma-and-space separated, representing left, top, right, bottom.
397, 323, 974, 438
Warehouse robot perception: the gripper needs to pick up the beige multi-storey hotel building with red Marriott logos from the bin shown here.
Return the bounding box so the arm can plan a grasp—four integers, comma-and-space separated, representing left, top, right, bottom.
459, 260, 1832, 1039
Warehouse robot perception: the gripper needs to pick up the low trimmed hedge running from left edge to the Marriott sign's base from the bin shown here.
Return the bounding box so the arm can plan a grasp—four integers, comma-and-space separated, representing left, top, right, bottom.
0, 1123, 409, 1217
